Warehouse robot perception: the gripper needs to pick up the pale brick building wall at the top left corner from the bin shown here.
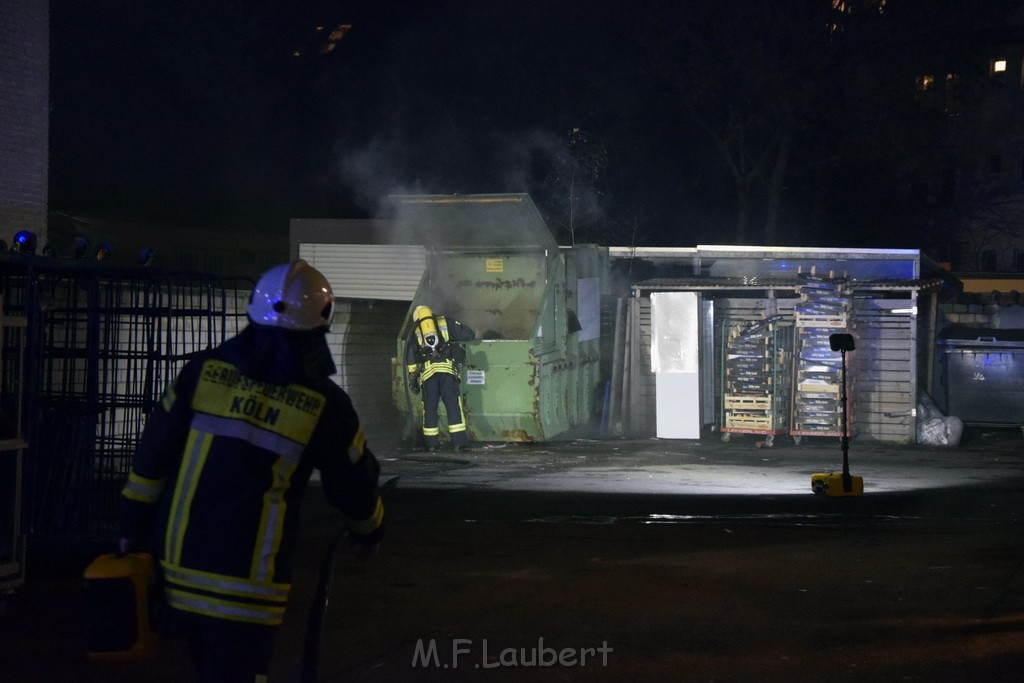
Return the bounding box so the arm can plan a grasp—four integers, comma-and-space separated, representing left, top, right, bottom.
0, 0, 50, 249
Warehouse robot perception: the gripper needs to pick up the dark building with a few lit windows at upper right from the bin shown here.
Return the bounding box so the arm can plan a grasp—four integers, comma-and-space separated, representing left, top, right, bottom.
914, 7, 1024, 273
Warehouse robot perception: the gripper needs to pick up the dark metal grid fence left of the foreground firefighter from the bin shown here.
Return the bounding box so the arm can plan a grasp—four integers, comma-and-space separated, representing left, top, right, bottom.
0, 259, 253, 541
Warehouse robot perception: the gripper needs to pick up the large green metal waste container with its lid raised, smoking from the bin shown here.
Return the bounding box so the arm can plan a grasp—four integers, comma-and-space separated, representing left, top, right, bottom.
392, 195, 608, 442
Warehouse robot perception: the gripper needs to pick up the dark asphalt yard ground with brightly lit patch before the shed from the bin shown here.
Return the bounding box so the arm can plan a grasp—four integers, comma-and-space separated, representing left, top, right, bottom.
0, 430, 1024, 681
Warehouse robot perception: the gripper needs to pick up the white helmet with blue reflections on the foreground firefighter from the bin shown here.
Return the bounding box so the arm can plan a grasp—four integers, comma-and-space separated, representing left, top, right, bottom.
249, 259, 334, 330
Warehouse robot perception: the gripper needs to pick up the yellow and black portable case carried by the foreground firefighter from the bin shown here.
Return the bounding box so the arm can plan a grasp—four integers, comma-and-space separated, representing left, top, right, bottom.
85, 553, 157, 661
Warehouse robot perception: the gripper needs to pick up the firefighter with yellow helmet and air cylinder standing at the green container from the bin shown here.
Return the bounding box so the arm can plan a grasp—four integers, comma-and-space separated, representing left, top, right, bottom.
406, 306, 476, 451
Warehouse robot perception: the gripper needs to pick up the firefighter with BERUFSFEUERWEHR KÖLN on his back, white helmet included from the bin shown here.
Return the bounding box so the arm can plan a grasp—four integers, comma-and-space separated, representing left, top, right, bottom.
120, 260, 384, 681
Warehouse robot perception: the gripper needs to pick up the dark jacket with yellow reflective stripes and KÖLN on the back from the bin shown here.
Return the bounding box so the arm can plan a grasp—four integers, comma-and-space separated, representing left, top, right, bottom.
122, 331, 383, 625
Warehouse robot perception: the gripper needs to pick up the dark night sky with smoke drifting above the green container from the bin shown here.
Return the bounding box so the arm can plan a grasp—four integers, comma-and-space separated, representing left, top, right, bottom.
50, 0, 1007, 246
